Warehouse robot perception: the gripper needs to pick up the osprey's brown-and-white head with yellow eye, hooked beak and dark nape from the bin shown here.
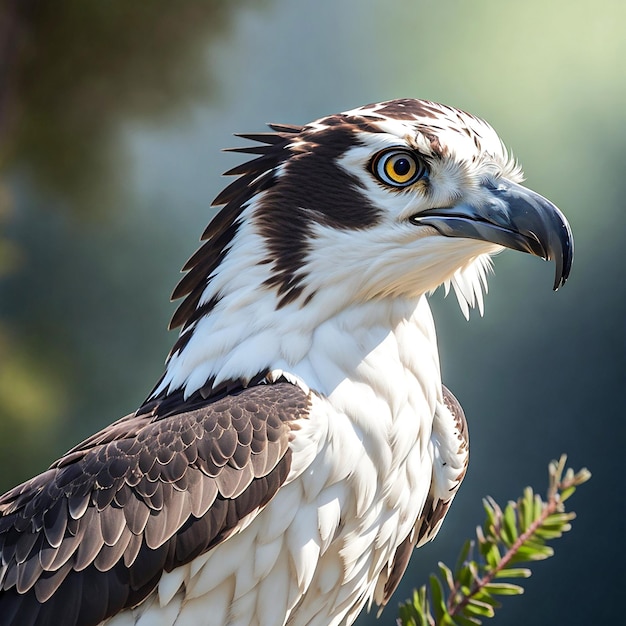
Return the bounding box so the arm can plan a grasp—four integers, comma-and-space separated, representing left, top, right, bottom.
155, 99, 573, 398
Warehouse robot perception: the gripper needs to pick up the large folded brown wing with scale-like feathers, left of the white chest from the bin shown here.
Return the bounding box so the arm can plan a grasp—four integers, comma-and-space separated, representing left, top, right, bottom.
0, 383, 309, 626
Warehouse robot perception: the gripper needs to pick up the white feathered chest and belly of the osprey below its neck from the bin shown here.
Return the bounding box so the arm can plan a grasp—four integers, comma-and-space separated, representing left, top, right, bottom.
110, 294, 441, 626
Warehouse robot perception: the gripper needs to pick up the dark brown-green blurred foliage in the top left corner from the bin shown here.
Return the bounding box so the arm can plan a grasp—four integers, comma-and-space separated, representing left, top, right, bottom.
0, 0, 263, 205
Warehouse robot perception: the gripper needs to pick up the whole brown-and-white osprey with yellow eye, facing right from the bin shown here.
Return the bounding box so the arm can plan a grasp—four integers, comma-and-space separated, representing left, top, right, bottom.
0, 99, 573, 626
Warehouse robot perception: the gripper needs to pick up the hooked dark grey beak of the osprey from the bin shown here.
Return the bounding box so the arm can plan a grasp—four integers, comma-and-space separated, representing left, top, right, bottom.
413, 180, 574, 290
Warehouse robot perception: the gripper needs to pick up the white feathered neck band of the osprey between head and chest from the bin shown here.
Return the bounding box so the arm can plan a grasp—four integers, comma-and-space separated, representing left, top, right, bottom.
154, 272, 439, 404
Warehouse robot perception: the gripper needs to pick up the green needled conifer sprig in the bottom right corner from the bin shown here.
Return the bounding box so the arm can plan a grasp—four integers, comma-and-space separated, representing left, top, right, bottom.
398, 455, 591, 626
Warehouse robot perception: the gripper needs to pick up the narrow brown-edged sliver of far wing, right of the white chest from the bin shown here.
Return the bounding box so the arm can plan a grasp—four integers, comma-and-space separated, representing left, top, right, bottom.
376, 385, 469, 610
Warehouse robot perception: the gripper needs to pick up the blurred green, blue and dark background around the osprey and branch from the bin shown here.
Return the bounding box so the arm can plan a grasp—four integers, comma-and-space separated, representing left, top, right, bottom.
0, 0, 626, 626
